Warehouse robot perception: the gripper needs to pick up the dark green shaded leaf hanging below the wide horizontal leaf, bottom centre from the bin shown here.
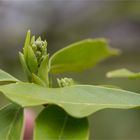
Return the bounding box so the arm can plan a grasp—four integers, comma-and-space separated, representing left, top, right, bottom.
34, 105, 89, 140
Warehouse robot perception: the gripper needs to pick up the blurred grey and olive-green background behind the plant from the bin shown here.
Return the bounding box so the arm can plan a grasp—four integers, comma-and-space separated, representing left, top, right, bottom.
0, 0, 140, 140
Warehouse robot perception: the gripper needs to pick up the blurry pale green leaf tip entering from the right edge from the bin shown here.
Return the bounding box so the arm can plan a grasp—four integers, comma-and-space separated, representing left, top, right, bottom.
107, 69, 140, 79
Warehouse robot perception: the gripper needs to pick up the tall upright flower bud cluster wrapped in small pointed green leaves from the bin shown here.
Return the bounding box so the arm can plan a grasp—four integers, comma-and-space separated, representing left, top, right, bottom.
19, 31, 49, 84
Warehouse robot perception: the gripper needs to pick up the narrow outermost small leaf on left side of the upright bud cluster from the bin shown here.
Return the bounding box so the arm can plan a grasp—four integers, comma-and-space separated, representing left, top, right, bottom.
19, 52, 32, 80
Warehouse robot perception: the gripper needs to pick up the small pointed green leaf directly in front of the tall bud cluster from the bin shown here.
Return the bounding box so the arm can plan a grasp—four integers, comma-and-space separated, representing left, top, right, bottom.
26, 46, 38, 72
